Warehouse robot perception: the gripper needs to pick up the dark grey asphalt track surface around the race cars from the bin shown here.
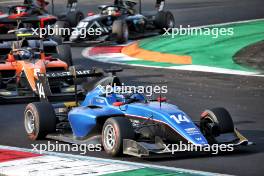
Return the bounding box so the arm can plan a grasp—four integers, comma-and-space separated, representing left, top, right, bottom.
0, 0, 264, 175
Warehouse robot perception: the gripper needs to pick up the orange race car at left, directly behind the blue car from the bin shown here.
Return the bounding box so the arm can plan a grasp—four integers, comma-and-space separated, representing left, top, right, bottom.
0, 34, 103, 103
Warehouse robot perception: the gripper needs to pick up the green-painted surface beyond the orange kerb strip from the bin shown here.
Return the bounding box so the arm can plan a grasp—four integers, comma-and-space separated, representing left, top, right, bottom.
140, 20, 264, 71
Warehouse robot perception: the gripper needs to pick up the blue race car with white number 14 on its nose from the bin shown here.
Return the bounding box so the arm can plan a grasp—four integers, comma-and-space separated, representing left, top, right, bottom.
25, 72, 251, 157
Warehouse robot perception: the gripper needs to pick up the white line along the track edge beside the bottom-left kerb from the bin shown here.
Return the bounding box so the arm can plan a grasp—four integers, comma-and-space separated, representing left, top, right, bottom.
0, 145, 227, 176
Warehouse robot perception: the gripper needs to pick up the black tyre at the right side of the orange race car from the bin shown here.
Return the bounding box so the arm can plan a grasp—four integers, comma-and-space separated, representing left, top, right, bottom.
57, 45, 73, 67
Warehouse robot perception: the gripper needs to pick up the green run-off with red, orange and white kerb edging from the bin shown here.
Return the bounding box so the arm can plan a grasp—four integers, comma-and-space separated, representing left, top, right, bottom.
83, 19, 264, 76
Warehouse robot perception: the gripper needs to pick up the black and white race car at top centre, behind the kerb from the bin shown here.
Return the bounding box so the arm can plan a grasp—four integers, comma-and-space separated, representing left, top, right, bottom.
70, 1, 175, 43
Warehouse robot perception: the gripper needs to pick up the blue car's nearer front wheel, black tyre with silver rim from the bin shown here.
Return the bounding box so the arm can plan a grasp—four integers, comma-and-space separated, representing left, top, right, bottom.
102, 117, 135, 156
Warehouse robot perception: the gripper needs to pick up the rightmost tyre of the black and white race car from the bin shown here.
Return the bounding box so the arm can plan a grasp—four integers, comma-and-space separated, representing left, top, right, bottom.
155, 11, 175, 33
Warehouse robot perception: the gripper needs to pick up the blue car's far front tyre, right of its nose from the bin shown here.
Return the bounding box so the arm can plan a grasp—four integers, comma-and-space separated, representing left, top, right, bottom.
200, 108, 234, 142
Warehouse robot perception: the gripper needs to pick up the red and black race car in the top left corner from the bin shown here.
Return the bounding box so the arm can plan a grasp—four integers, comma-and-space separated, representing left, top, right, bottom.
0, 0, 84, 38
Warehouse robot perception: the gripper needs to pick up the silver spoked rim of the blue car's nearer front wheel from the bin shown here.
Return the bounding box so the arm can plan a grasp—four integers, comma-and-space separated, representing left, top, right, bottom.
104, 124, 116, 150
